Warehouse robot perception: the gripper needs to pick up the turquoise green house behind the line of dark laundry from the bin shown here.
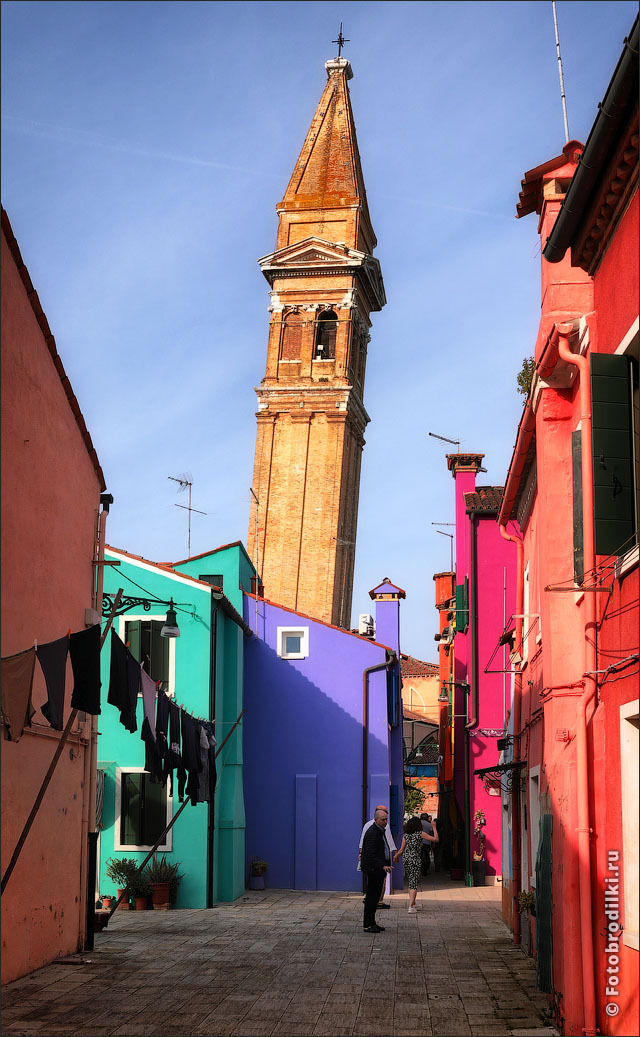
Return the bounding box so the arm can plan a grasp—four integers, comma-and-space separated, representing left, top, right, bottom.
98, 542, 254, 907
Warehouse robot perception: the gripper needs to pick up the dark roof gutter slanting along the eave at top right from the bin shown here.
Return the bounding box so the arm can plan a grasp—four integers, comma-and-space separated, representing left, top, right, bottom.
542, 18, 638, 262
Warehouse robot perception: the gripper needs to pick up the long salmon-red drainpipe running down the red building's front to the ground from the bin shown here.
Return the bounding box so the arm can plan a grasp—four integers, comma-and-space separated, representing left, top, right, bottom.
553, 324, 597, 1035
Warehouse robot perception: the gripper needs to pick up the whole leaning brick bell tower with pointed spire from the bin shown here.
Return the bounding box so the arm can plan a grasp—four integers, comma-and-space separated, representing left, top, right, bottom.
248, 57, 386, 626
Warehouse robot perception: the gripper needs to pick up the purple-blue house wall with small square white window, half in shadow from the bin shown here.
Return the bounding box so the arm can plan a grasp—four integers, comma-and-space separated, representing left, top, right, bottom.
243, 596, 401, 890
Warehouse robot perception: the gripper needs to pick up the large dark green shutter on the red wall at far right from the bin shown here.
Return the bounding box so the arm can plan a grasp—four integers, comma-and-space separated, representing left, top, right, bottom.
591, 353, 635, 555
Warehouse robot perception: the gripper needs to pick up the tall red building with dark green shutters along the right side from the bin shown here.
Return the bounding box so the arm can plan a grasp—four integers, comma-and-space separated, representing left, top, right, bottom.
499, 22, 640, 1035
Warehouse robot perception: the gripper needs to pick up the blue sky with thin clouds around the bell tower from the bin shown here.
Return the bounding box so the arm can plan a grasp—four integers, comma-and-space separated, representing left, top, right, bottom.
2, 0, 637, 660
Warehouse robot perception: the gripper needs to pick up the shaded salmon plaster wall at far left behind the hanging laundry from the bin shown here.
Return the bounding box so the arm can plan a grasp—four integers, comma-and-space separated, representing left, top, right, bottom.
1, 222, 101, 982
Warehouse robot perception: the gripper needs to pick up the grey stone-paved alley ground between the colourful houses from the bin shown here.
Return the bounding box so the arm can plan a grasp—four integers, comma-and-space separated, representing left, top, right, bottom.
2, 875, 555, 1037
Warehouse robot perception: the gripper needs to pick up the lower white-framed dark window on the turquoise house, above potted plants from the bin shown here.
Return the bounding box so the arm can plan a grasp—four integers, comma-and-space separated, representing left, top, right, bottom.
113, 767, 173, 850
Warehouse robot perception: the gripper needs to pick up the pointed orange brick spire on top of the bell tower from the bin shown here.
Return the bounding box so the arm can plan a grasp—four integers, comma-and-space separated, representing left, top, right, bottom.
276, 58, 377, 253
